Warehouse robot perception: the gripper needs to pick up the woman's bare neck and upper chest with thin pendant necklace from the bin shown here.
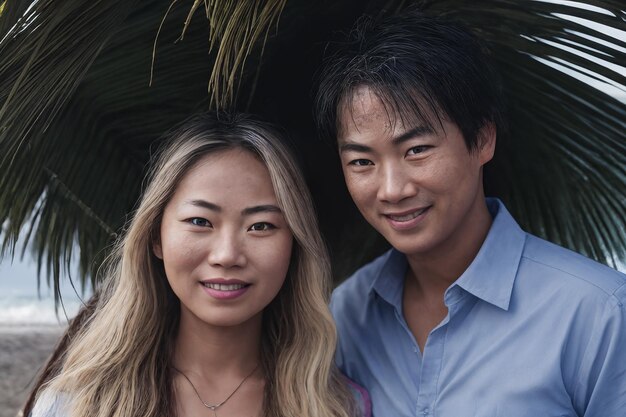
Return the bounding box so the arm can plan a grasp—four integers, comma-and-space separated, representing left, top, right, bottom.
172, 311, 265, 417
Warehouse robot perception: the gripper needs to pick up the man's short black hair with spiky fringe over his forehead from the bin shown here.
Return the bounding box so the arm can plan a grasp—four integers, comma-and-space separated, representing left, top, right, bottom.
315, 8, 503, 151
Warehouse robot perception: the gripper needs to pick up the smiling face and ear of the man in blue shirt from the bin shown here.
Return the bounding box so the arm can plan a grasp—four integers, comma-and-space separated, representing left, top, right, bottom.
338, 87, 495, 257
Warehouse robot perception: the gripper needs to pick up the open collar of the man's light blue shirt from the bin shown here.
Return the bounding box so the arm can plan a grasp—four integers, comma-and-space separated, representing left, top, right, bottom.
370, 198, 526, 310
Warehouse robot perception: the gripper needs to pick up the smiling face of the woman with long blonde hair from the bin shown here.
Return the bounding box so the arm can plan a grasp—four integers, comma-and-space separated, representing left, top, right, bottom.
154, 149, 293, 326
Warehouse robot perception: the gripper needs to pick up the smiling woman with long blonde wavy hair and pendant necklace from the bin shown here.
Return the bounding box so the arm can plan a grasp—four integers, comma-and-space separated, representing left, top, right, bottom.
33, 114, 369, 417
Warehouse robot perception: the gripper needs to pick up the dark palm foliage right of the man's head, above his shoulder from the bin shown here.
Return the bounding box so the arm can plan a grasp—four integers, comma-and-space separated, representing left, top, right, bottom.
414, 0, 626, 266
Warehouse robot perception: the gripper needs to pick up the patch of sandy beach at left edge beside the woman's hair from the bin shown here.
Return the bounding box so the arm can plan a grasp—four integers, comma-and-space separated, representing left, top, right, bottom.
0, 326, 63, 417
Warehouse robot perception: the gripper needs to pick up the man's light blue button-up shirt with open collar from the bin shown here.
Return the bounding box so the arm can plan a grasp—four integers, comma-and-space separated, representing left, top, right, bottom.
331, 200, 626, 417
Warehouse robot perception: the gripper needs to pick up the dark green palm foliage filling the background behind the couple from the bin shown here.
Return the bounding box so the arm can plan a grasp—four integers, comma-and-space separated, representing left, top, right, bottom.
0, 0, 626, 296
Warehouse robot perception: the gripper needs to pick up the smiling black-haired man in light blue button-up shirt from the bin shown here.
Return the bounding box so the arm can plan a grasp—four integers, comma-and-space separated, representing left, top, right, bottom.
317, 11, 626, 417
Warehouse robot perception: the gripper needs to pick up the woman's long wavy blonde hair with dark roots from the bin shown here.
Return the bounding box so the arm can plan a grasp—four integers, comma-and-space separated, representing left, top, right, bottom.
42, 113, 355, 417
